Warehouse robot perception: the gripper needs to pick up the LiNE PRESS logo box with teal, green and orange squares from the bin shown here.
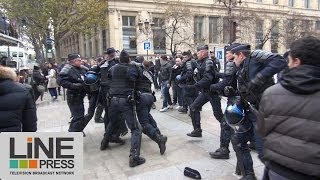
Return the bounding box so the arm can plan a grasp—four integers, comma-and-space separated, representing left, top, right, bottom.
0, 132, 83, 180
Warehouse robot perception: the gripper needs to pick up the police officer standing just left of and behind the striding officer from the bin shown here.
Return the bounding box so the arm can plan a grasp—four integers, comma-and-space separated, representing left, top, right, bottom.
176, 51, 198, 113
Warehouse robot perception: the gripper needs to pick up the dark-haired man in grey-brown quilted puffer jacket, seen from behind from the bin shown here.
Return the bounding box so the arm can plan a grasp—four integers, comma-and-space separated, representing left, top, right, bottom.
258, 37, 320, 180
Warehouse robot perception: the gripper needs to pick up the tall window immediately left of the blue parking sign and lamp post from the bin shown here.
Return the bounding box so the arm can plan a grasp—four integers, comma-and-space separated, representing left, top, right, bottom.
122, 16, 137, 54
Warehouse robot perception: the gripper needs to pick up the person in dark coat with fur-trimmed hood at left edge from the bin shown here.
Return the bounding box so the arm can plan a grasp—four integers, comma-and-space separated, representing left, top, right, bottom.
0, 65, 37, 132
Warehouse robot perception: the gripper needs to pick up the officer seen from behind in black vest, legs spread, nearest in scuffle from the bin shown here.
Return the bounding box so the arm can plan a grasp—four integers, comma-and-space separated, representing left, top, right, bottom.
101, 50, 145, 167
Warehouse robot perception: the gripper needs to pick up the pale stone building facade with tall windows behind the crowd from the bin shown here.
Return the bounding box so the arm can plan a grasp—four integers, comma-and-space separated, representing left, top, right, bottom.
60, 0, 320, 58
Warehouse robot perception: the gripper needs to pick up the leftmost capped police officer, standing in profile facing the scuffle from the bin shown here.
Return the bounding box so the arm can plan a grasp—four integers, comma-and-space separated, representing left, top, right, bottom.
58, 53, 86, 132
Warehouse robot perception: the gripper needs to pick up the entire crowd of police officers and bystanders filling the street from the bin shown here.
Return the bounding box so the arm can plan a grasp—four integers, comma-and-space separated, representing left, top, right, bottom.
0, 37, 320, 180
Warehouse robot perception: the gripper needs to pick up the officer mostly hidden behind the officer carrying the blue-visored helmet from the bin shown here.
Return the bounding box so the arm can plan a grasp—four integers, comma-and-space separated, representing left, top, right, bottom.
209, 43, 240, 159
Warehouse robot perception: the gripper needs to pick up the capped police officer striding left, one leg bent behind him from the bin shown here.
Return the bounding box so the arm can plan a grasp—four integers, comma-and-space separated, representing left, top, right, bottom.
187, 45, 223, 137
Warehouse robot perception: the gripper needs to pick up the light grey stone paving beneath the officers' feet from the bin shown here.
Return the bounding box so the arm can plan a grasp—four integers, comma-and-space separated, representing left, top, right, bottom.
37, 92, 263, 180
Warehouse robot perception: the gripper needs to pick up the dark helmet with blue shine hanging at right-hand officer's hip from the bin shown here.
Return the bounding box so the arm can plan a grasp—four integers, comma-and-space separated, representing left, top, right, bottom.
225, 100, 252, 133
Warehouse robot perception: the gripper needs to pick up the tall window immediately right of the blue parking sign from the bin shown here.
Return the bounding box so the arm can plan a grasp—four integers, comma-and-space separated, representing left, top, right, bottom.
153, 18, 166, 54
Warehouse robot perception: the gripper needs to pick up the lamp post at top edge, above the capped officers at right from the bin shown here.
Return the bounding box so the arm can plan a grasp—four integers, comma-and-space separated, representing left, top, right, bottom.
218, 0, 242, 44
